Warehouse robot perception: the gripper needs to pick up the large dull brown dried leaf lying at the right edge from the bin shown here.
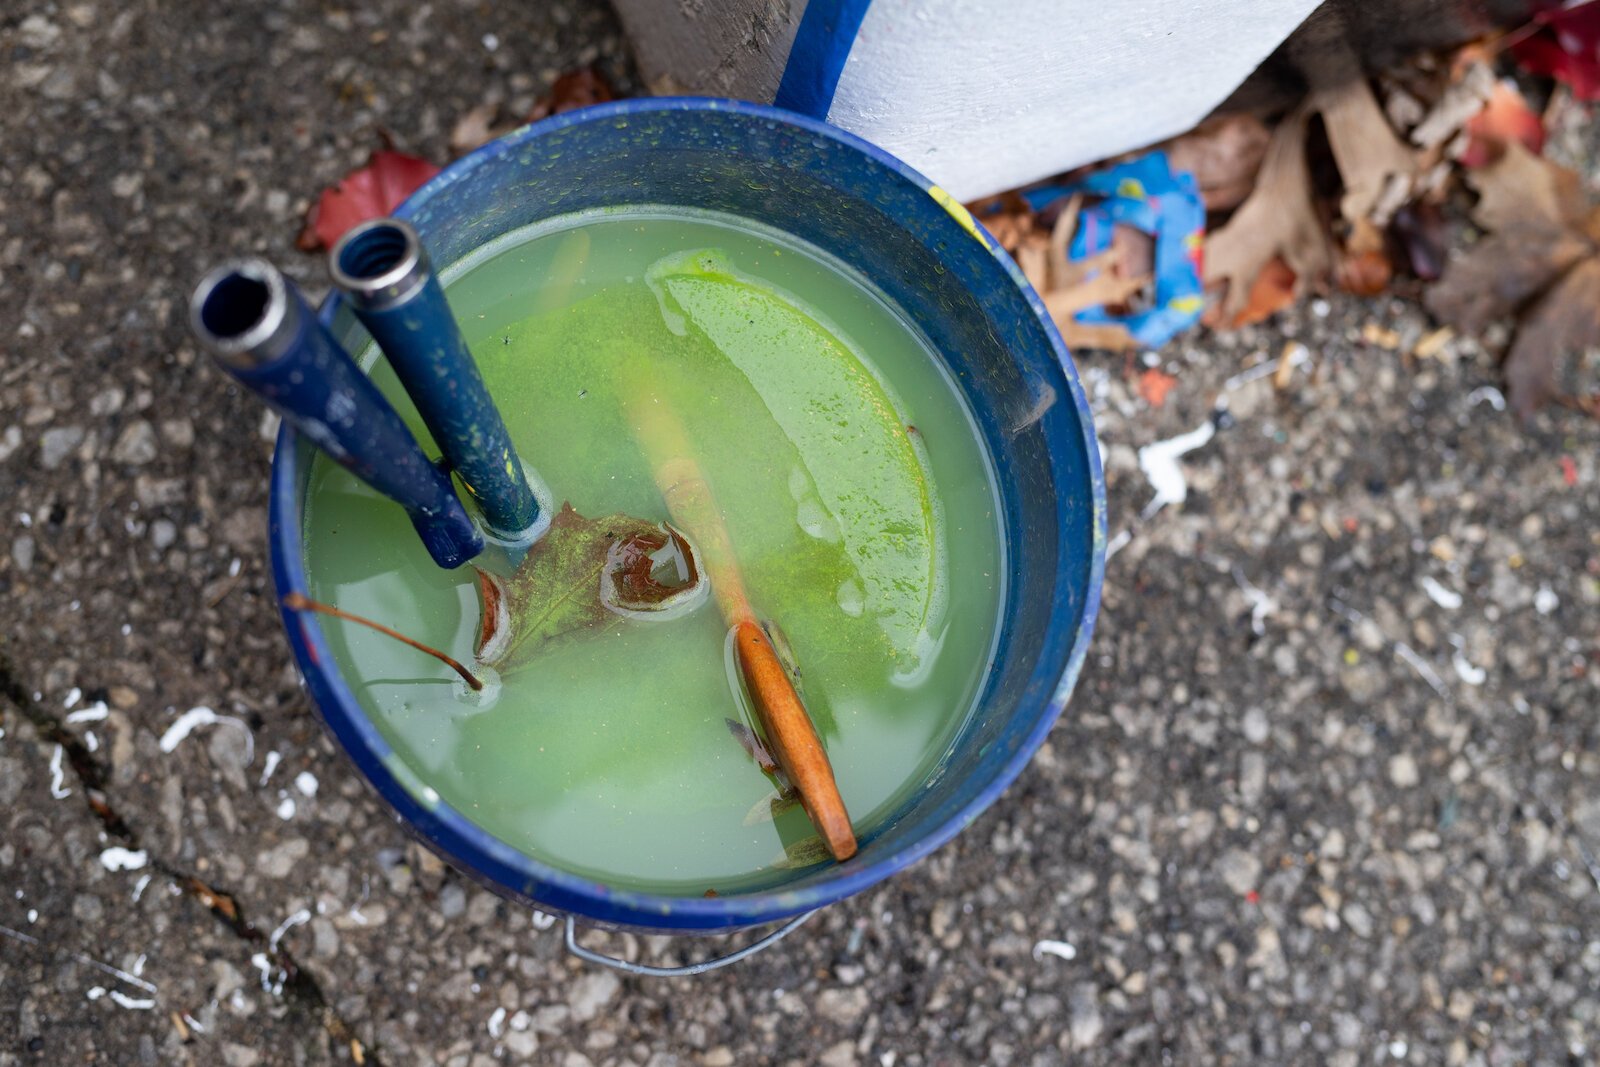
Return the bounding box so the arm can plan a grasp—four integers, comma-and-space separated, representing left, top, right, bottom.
1426, 141, 1600, 416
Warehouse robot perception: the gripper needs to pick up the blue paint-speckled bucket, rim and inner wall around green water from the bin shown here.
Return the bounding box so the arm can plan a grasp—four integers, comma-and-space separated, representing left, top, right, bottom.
270, 99, 1106, 933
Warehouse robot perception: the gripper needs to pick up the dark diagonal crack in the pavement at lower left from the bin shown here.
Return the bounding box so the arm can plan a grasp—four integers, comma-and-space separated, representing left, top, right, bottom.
0, 649, 382, 1067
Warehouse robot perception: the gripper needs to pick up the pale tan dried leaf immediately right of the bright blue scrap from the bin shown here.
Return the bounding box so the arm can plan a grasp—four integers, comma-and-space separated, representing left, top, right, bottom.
1205, 107, 1333, 322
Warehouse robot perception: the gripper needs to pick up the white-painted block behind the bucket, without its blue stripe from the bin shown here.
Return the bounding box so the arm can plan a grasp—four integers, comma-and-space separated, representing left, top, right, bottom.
614, 0, 1320, 200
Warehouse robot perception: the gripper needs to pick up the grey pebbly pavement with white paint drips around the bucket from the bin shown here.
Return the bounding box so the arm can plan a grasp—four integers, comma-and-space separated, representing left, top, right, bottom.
0, 0, 1600, 1067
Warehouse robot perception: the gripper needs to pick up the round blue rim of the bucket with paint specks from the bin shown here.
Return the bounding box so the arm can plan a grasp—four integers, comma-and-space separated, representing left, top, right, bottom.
269, 96, 1106, 933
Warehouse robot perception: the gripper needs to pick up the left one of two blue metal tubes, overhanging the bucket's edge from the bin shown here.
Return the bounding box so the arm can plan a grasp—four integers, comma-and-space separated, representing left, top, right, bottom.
189, 259, 483, 568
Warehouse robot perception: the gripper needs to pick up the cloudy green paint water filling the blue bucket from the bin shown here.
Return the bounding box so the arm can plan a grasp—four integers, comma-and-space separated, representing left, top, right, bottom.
306, 213, 1003, 896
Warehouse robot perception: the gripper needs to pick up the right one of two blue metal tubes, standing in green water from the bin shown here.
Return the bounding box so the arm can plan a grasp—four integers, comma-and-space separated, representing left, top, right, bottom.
328, 219, 539, 542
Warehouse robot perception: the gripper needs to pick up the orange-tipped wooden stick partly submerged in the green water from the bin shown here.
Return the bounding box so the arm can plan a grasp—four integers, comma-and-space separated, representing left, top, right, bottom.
627, 383, 856, 861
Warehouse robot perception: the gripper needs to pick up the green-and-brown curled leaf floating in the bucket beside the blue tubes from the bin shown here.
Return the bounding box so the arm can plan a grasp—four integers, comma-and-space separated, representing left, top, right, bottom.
477, 504, 709, 670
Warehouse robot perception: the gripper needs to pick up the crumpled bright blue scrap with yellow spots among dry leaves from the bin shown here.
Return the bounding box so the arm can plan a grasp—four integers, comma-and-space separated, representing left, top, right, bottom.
1022, 152, 1205, 349
